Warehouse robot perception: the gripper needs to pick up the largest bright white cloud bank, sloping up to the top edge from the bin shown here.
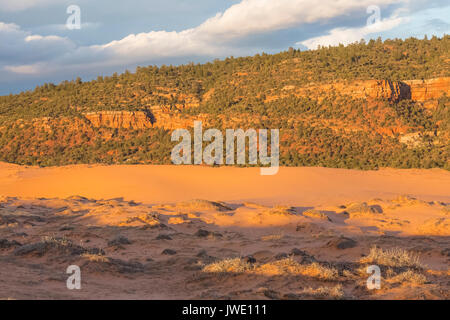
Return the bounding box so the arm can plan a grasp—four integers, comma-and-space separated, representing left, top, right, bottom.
95, 0, 398, 62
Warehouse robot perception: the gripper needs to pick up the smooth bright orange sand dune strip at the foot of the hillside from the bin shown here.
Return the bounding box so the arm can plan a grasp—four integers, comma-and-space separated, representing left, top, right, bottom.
0, 163, 450, 206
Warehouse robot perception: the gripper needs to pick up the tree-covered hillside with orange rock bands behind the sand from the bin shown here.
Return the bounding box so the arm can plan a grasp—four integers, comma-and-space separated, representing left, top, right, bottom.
0, 36, 450, 170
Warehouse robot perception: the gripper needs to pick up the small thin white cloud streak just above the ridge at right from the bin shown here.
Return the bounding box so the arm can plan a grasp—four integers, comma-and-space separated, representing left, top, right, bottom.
297, 17, 406, 49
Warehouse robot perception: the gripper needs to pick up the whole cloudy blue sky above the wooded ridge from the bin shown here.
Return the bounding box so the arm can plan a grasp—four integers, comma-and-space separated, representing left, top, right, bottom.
0, 0, 450, 95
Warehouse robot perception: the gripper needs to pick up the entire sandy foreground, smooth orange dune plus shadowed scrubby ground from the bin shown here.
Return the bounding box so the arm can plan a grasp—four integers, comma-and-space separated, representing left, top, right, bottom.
0, 163, 450, 299
